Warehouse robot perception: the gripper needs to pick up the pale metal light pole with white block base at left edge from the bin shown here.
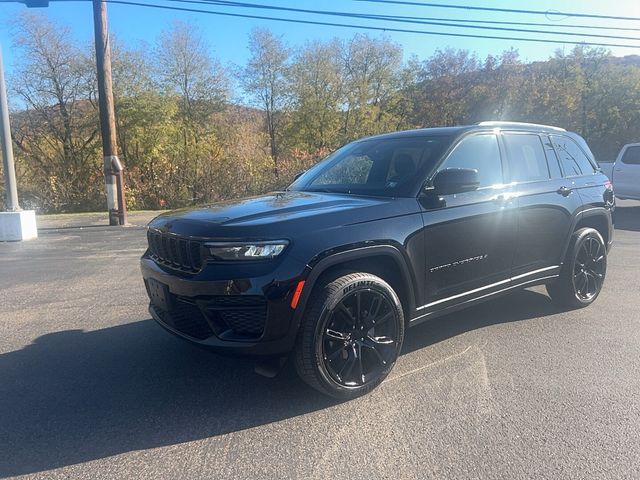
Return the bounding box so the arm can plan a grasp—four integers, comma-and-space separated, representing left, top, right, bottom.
0, 42, 38, 242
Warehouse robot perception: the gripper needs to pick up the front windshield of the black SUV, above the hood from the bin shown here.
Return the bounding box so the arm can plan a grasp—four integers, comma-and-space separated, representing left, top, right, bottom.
288, 136, 450, 196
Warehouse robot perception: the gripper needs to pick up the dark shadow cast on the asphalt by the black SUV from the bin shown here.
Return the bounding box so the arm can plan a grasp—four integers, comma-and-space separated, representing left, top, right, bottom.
0, 291, 555, 478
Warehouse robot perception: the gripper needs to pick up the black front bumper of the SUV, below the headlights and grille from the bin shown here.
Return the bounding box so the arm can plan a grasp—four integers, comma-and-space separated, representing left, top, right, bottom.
141, 254, 305, 356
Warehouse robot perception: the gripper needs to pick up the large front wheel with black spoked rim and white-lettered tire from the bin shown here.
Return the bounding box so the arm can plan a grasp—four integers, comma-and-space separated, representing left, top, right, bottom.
294, 273, 405, 400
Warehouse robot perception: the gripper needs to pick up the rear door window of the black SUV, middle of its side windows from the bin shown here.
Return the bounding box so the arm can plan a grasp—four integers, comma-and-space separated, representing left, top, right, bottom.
503, 133, 550, 182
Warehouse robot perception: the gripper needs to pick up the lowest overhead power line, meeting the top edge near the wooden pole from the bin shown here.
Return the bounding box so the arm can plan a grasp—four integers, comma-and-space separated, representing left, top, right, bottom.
99, 0, 640, 48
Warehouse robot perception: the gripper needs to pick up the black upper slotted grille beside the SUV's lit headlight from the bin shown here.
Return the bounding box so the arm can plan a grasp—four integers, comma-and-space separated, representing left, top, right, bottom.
147, 229, 202, 273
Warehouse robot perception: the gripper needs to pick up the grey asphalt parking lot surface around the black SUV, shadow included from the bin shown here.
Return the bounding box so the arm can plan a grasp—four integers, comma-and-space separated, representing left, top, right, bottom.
0, 201, 640, 480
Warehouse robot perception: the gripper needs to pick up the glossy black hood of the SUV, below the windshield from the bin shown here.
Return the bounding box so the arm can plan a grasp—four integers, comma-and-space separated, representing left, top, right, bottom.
149, 192, 412, 238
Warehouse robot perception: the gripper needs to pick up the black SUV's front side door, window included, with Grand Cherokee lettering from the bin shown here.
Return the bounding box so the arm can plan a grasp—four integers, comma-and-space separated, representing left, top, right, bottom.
421, 132, 517, 312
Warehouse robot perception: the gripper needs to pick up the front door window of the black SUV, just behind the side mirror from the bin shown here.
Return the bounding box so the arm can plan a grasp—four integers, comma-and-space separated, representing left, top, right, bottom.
440, 135, 503, 187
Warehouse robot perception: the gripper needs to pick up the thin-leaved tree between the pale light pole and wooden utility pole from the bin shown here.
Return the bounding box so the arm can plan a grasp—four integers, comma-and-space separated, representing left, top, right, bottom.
11, 12, 104, 211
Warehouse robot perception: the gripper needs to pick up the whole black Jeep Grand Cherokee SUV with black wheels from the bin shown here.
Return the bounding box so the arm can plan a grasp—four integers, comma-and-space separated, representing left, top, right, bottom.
142, 122, 615, 398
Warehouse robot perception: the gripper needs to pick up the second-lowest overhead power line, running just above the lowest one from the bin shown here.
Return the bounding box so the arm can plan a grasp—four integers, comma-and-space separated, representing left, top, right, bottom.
160, 0, 640, 41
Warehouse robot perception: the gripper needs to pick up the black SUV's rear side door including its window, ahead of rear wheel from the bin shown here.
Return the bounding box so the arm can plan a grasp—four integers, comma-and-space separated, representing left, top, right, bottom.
502, 131, 581, 282
